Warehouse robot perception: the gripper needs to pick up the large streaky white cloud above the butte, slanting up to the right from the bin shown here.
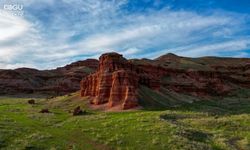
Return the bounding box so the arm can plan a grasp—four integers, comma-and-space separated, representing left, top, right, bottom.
78, 11, 235, 50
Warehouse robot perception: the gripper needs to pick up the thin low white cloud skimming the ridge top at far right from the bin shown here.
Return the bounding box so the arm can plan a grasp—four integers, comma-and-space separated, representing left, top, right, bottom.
142, 38, 250, 58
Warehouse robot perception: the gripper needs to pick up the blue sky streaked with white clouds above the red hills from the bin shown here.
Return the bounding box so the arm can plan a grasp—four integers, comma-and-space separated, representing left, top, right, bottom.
0, 0, 250, 69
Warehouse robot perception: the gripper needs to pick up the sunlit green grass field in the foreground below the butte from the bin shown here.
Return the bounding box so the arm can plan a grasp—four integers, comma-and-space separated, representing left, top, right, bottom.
0, 94, 250, 150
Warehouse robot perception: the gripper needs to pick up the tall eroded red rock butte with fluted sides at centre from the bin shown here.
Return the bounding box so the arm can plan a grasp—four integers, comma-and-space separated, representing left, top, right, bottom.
81, 53, 159, 109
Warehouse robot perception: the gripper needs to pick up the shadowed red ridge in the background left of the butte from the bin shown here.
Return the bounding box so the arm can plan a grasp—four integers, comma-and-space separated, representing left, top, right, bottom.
0, 59, 98, 95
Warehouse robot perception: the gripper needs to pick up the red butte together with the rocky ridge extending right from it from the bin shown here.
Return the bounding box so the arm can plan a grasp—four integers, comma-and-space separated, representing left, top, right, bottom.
81, 53, 250, 109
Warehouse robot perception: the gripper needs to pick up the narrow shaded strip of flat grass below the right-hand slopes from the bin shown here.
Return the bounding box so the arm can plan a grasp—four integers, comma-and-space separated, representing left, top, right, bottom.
142, 98, 250, 116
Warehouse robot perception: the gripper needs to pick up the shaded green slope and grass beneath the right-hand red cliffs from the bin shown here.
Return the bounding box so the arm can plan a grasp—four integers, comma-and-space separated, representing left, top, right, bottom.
139, 86, 250, 116
